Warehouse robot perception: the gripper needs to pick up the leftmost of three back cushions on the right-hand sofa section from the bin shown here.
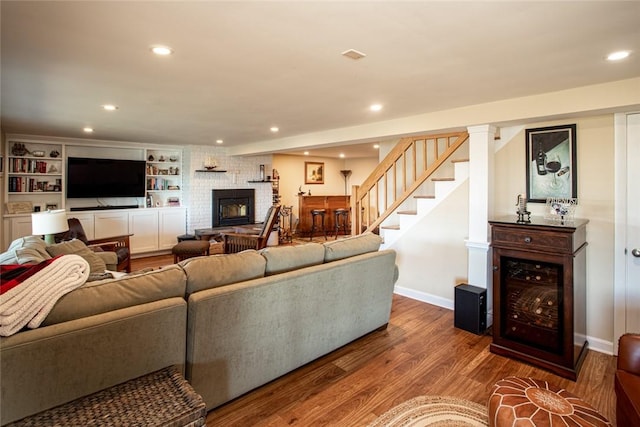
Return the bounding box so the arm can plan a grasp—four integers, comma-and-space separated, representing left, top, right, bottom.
179, 250, 267, 298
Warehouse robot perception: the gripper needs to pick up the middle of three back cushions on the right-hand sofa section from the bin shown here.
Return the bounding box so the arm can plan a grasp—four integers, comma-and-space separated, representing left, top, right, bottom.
260, 243, 324, 276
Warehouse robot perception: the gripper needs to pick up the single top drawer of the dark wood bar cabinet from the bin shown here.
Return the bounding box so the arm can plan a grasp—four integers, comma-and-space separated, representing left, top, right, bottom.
491, 226, 573, 254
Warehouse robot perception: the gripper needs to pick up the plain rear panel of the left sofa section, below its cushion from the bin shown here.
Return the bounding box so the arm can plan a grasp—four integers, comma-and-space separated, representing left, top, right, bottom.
0, 298, 187, 425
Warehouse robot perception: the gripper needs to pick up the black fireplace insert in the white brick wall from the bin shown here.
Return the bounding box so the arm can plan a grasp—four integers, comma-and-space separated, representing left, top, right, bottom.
211, 188, 255, 227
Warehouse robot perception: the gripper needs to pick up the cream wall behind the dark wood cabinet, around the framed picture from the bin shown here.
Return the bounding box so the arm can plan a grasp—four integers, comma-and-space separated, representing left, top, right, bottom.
494, 114, 614, 351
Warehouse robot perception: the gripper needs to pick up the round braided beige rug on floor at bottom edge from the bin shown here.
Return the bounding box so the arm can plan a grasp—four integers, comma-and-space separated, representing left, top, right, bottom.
369, 396, 489, 427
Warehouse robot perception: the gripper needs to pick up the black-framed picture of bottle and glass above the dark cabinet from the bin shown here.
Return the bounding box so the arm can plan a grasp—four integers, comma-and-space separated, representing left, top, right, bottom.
526, 124, 578, 203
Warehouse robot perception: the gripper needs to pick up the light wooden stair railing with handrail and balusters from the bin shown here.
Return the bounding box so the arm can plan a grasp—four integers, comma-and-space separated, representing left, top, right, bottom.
351, 131, 469, 234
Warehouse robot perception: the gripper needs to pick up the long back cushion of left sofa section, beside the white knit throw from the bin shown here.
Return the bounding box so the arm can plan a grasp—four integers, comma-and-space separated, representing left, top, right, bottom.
43, 265, 187, 326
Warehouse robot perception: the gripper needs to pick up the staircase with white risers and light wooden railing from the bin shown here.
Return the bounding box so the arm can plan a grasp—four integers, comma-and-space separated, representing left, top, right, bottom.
351, 132, 469, 247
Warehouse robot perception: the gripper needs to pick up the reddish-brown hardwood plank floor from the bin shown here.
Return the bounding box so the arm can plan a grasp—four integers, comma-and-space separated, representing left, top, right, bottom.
134, 257, 616, 427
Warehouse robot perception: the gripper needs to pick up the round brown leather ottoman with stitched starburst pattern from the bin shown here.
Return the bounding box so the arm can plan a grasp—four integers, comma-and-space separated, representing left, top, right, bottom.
489, 377, 611, 427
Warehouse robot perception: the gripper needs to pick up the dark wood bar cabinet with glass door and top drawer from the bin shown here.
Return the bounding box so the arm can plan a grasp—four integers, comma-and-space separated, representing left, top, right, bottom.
489, 217, 588, 381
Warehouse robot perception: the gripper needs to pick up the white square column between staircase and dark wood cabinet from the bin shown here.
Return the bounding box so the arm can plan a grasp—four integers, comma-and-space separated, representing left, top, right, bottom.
467, 125, 496, 326
